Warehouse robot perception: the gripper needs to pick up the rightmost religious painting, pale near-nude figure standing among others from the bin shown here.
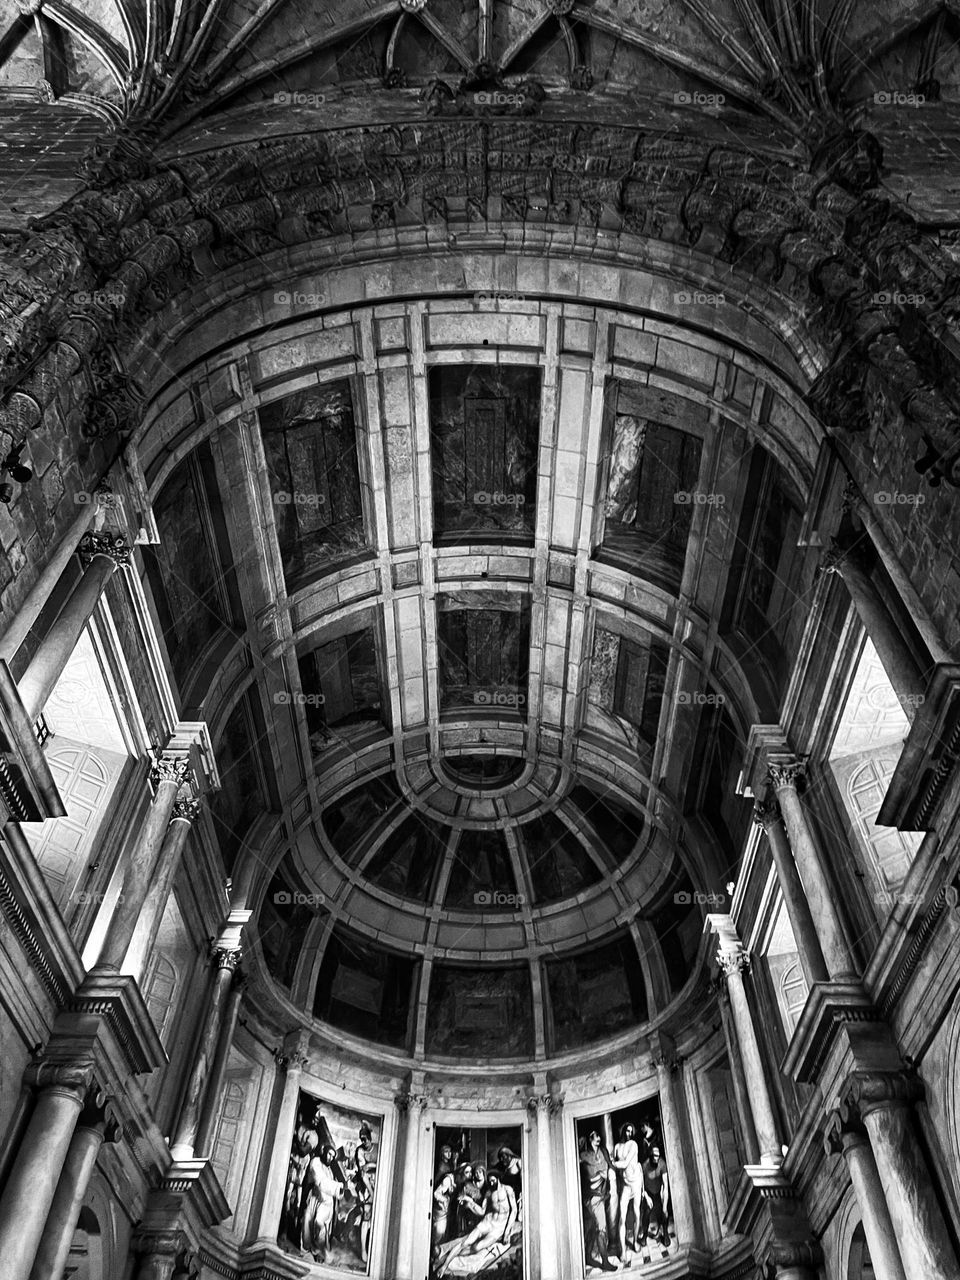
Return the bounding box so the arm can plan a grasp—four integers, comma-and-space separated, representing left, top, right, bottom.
575, 1098, 677, 1276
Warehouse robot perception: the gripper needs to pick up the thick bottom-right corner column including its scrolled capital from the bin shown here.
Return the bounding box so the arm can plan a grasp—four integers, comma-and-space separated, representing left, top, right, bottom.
845, 1071, 960, 1280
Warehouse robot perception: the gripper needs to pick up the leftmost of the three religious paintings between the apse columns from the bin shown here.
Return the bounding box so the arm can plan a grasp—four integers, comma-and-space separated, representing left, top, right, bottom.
278, 1092, 383, 1275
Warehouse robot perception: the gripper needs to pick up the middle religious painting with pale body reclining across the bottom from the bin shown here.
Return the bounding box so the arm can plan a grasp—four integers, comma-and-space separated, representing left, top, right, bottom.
430, 1125, 527, 1280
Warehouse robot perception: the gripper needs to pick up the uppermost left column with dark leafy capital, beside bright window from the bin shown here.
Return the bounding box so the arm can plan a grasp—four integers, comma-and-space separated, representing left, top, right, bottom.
17, 534, 131, 721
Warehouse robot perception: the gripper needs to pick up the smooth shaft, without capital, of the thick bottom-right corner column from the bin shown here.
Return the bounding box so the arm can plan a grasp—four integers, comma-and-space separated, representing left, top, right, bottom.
863, 1102, 960, 1280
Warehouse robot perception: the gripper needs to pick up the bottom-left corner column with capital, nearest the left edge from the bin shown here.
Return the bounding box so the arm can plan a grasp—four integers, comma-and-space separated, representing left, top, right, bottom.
0, 1064, 92, 1280
